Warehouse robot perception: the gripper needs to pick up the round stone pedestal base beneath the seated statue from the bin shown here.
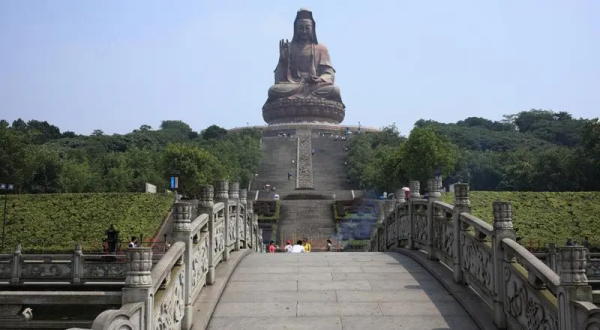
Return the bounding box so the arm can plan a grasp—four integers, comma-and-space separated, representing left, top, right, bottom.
263, 98, 346, 125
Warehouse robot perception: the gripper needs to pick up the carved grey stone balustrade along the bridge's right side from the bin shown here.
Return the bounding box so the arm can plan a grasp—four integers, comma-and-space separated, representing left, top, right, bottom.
370, 178, 600, 330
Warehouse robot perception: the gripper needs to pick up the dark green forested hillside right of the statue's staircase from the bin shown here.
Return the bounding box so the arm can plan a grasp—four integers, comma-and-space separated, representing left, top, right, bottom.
348, 110, 600, 193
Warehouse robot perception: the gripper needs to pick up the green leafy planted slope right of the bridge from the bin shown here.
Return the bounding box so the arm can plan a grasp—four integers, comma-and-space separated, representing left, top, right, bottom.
442, 191, 600, 248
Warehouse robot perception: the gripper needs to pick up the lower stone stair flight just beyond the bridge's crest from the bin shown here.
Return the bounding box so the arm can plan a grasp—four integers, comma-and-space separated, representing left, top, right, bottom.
277, 200, 338, 250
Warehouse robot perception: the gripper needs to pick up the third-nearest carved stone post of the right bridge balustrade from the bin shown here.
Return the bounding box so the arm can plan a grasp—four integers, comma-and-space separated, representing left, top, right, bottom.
452, 183, 471, 283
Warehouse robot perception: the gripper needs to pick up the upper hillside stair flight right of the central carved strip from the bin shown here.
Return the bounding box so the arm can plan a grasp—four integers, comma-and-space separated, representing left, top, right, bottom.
312, 137, 353, 190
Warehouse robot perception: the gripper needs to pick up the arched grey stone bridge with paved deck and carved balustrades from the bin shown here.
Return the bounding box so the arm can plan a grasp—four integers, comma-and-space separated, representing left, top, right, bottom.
0, 179, 600, 330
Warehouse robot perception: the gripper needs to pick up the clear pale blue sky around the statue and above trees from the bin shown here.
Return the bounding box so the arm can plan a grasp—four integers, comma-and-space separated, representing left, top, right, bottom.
0, 0, 600, 134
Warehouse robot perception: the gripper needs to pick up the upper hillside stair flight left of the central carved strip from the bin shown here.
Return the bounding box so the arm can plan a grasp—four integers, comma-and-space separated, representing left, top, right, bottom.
252, 137, 298, 195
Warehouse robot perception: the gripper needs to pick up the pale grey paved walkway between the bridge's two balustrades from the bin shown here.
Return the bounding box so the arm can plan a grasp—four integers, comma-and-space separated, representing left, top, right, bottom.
208, 252, 478, 330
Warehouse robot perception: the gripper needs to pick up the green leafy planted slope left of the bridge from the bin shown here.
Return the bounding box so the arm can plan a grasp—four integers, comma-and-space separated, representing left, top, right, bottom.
0, 193, 174, 253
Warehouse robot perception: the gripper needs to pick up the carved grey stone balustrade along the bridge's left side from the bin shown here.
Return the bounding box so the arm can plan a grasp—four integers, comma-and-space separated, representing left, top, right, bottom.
59, 180, 263, 330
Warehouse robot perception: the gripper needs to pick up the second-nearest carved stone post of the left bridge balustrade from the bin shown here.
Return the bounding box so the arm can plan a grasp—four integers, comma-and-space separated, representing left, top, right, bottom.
171, 202, 194, 330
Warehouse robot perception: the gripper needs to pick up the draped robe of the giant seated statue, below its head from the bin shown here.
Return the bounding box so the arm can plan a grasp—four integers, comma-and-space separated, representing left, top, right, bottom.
267, 42, 342, 103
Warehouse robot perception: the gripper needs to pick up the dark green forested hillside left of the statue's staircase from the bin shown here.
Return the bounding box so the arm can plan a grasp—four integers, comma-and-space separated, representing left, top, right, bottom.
0, 119, 261, 197
